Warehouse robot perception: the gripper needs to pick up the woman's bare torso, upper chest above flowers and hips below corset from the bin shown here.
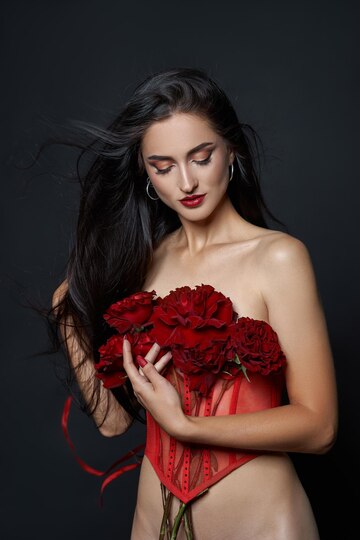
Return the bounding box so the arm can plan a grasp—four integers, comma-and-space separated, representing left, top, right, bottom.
131, 224, 319, 540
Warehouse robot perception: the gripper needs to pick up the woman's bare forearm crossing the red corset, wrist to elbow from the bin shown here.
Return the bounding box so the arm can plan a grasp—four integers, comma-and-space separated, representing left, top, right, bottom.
178, 404, 335, 453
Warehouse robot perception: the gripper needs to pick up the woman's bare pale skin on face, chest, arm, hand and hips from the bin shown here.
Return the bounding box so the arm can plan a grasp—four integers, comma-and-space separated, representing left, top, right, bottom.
55, 113, 338, 540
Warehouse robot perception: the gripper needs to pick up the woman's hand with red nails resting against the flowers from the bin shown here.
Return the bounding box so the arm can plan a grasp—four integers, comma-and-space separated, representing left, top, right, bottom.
123, 338, 187, 438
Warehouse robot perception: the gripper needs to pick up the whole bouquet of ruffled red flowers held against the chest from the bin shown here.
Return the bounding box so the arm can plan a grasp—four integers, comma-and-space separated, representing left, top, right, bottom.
95, 284, 286, 396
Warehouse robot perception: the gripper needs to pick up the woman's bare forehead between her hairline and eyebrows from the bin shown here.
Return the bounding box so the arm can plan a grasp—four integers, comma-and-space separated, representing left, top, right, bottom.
141, 113, 220, 155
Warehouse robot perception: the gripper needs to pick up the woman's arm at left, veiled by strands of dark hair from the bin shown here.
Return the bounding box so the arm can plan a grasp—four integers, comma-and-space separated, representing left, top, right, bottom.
52, 280, 133, 437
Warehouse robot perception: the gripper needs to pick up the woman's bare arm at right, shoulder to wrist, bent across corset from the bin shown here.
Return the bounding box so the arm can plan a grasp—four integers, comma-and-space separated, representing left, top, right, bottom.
177, 235, 338, 454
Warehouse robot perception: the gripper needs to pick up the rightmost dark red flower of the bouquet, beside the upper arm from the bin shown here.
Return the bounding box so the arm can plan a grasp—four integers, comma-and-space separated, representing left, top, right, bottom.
230, 317, 286, 375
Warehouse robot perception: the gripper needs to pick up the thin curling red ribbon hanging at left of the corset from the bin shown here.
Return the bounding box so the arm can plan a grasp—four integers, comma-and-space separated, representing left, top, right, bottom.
61, 396, 145, 507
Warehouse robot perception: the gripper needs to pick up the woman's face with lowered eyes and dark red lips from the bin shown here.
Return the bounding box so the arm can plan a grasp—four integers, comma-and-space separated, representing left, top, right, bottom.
141, 113, 234, 220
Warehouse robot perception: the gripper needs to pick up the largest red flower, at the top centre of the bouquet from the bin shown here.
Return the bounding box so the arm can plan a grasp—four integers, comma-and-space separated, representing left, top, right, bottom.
151, 284, 237, 350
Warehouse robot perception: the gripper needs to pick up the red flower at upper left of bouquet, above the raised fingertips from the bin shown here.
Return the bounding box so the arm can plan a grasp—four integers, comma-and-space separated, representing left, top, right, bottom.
103, 291, 156, 334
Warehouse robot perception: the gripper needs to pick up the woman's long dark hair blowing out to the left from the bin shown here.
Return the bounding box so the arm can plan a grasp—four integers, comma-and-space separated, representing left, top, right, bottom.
28, 68, 284, 430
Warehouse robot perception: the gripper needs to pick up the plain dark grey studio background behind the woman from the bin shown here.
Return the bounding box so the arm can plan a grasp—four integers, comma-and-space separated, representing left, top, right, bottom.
0, 0, 359, 540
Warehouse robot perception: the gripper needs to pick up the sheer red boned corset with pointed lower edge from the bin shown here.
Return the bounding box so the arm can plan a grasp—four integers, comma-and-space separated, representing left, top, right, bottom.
144, 363, 284, 503
